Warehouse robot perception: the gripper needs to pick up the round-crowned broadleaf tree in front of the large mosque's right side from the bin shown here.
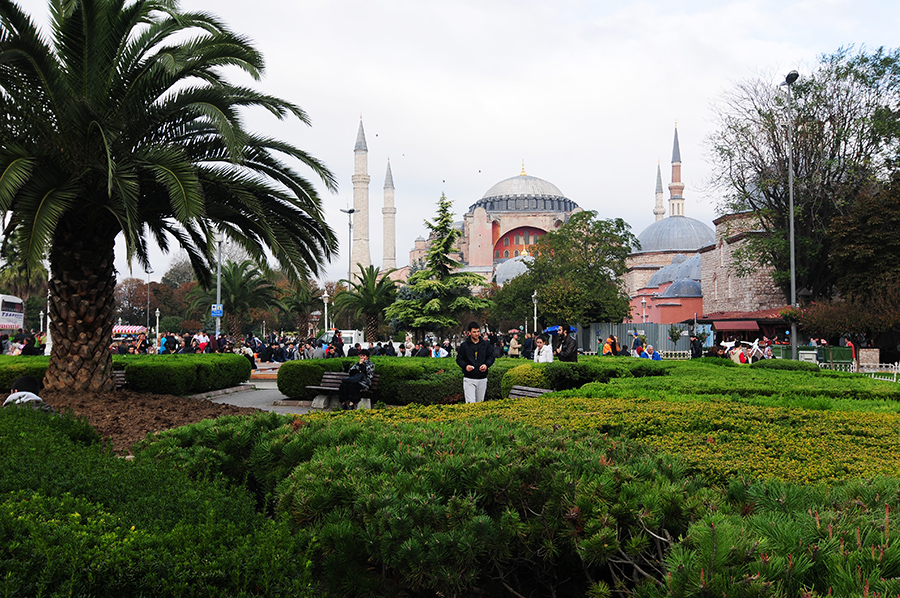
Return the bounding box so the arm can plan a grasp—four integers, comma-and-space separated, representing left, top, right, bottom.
524, 211, 639, 323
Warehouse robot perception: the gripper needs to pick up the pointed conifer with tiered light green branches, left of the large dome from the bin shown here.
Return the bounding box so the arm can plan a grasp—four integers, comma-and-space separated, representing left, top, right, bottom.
385, 193, 492, 334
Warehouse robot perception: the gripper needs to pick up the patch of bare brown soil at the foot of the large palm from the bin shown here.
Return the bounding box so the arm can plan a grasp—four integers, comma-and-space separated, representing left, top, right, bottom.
41, 390, 259, 455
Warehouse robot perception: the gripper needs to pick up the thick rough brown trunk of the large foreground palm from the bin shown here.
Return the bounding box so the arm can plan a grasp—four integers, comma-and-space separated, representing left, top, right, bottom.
44, 218, 116, 393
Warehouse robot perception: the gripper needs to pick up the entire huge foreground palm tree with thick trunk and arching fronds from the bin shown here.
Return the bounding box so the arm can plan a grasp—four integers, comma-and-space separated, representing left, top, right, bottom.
0, 0, 337, 392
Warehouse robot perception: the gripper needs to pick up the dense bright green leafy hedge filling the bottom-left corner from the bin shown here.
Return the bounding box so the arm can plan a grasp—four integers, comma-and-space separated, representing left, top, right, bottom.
0, 409, 318, 597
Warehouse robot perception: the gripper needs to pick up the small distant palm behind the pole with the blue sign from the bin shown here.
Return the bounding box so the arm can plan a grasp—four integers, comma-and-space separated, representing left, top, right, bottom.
188, 260, 287, 339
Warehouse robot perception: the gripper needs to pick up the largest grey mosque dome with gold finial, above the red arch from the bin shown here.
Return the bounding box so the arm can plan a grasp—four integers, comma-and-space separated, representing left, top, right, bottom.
469, 171, 578, 213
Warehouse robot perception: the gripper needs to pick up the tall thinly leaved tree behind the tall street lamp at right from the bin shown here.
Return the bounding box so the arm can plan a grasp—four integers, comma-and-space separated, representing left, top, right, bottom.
709, 48, 900, 298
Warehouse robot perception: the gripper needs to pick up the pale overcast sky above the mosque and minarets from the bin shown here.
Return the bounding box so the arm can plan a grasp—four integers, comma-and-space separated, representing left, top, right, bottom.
22, 0, 900, 280
